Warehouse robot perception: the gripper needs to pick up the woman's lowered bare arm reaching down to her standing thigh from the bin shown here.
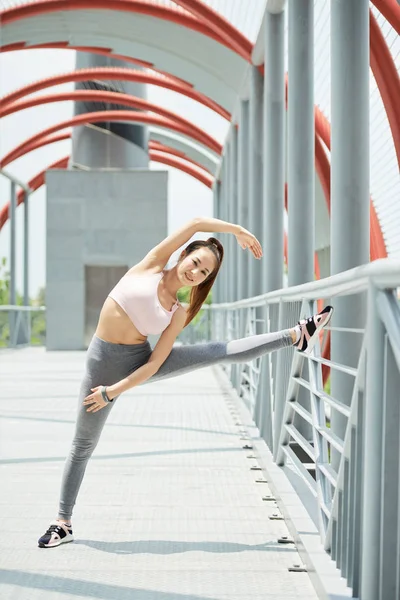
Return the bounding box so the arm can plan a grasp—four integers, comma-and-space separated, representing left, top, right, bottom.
83, 307, 187, 412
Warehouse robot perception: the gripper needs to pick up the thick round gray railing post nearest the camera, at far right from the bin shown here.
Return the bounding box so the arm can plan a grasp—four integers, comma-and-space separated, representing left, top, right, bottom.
360, 283, 386, 600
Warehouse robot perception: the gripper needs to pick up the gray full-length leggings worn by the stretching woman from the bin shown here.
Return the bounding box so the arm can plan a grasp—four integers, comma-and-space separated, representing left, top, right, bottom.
59, 330, 293, 519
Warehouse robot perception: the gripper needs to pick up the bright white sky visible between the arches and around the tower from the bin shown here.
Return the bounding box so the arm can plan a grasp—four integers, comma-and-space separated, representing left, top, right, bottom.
0, 50, 228, 296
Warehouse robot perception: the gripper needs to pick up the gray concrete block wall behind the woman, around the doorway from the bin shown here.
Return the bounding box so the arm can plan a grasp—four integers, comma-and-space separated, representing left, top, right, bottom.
46, 170, 168, 350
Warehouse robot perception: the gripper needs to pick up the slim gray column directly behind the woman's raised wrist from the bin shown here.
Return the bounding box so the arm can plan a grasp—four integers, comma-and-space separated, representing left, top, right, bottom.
236, 100, 249, 300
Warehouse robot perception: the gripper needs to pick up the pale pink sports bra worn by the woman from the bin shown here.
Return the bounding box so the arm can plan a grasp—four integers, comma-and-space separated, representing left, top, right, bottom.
108, 272, 179, 336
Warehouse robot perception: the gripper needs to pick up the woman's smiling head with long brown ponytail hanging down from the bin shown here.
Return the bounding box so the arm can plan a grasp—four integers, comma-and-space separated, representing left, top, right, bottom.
177, 238, 224, 326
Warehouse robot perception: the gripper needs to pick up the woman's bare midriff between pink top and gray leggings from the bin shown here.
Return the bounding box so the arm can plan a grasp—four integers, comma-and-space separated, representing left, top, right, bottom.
96, 297, 147, 344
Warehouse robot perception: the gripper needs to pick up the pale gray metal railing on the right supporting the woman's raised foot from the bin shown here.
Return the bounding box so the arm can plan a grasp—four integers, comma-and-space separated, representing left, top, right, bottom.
184, 259, 400, 600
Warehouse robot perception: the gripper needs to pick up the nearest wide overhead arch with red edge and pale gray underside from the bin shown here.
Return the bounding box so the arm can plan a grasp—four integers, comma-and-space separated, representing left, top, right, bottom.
0, 0, 251, 112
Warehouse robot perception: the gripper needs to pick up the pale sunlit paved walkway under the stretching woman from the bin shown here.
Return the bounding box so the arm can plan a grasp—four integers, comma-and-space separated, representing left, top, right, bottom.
0, 349, 316, 600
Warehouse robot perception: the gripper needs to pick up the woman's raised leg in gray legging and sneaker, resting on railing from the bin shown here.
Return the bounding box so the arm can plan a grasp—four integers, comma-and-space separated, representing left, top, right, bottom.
145, 306, 333, 383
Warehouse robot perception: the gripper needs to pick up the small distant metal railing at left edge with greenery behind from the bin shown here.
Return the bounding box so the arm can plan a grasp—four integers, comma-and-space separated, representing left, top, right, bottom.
0, 305, 46, 348
